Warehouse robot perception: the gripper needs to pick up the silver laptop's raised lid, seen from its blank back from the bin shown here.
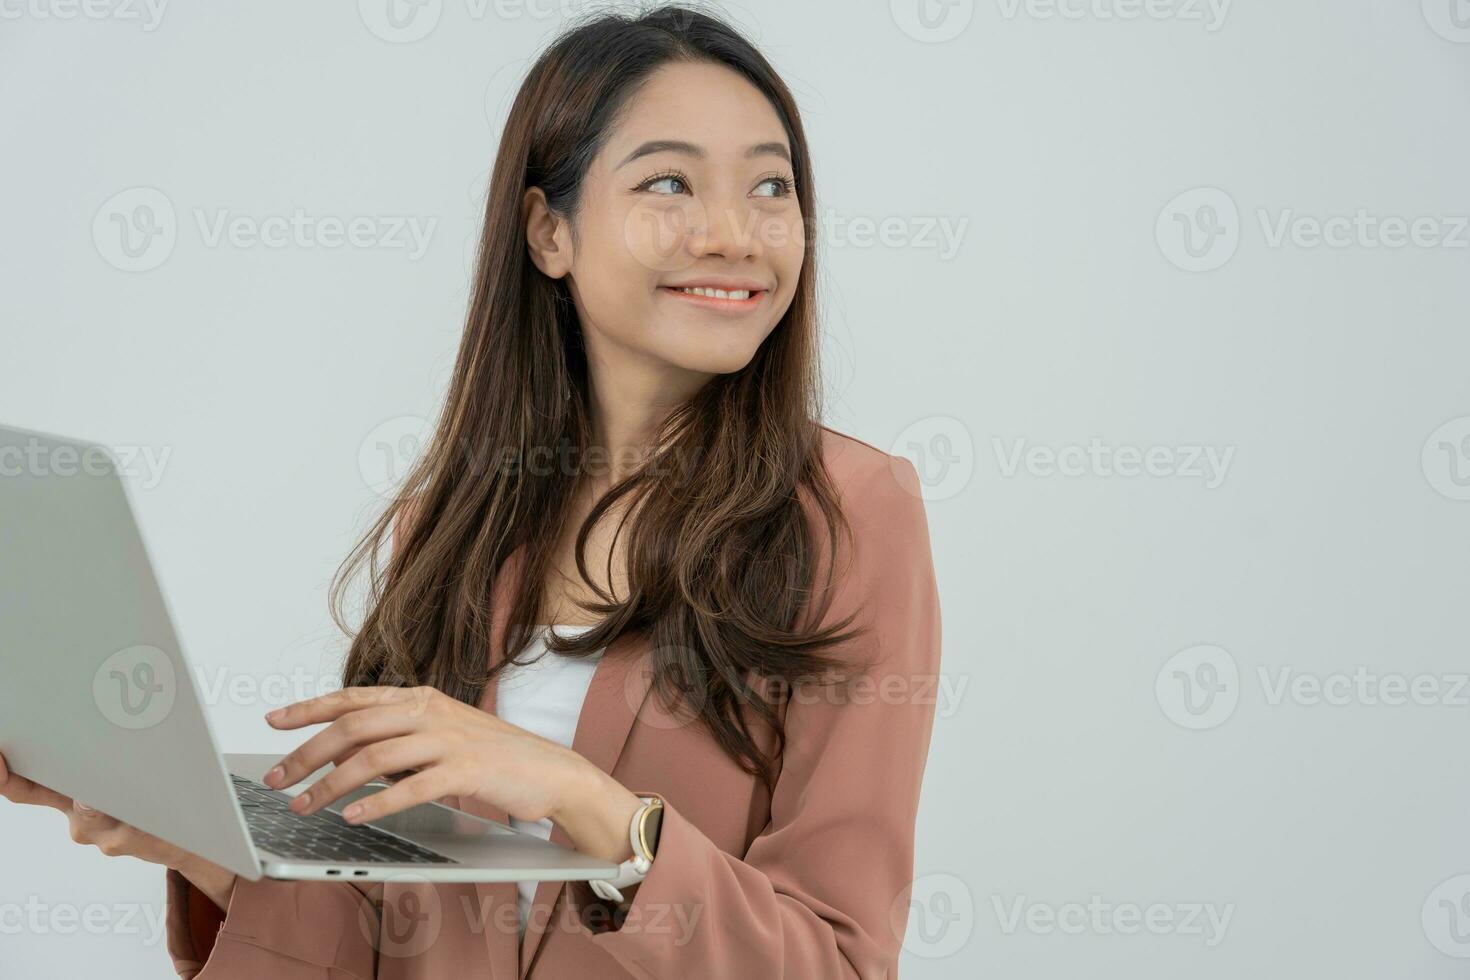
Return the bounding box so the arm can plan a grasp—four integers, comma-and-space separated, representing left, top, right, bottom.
0, 426, 262, 880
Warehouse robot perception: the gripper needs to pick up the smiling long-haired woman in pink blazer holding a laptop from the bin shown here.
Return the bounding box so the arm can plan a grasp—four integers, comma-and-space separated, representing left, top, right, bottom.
0, 7, 939, 980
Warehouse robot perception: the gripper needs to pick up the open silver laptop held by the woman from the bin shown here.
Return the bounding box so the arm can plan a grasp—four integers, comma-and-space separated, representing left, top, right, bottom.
0, 426, 617, 882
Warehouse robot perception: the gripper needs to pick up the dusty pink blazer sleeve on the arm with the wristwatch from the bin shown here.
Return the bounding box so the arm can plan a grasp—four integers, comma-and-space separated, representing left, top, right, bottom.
566, 457, 939, 980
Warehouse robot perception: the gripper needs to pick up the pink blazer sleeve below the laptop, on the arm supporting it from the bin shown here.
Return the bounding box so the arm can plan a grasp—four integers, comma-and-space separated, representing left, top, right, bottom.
166, 502, 429, 980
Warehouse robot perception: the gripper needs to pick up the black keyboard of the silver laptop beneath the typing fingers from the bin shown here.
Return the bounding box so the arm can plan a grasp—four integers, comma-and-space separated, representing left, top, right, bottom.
229, 774, 459, 864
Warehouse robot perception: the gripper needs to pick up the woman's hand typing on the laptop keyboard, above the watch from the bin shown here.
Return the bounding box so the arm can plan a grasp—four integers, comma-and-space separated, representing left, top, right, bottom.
266, 688, 639, 861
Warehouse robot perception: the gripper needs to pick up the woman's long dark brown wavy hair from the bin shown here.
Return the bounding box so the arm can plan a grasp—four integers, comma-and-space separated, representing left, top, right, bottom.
331, 6, 860, 788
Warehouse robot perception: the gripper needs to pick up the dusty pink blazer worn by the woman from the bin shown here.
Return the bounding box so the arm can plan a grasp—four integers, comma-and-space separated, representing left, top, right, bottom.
168, 429, 939, 980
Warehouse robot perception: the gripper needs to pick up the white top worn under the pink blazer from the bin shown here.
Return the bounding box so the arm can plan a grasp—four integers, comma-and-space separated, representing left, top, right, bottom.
495, 623, 603, 933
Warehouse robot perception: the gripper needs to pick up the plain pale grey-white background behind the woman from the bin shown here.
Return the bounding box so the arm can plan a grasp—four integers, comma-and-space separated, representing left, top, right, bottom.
0, 0, 1470, 980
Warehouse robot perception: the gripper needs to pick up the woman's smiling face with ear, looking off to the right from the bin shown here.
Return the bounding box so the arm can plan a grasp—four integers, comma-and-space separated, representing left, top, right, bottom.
526, 63, 804, 394
